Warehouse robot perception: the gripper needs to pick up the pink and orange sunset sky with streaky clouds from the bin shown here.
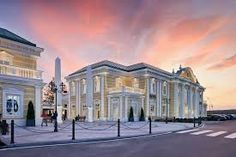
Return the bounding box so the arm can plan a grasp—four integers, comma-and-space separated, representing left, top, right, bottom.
0, 0, 236, 109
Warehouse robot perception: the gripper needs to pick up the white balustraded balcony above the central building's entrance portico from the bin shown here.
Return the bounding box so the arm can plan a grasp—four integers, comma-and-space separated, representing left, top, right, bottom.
108, 86, 145, 94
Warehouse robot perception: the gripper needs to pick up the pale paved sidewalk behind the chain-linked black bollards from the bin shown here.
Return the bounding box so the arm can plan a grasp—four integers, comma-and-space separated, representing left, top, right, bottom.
0, 121, 193, 146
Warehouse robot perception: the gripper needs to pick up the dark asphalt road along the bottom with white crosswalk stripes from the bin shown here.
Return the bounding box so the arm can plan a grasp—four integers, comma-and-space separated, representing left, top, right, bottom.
0, 120, 236, 157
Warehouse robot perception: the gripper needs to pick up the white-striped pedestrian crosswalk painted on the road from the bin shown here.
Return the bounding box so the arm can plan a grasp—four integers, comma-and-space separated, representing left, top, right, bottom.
176, 128, 236, 139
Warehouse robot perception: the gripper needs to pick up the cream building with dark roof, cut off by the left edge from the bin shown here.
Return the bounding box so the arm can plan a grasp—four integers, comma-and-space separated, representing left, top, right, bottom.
0, 28, 44, 125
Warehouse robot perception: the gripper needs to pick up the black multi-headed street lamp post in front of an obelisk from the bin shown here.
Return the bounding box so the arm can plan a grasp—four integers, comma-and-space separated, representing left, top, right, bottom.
48, 80, 65, 132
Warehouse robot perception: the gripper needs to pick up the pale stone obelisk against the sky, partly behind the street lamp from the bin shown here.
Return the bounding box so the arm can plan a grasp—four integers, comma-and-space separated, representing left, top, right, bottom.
55, 57, 62, 123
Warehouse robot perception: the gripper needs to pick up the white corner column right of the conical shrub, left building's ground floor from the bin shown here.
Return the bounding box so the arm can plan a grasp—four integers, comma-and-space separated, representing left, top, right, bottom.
35, 86, 42, 125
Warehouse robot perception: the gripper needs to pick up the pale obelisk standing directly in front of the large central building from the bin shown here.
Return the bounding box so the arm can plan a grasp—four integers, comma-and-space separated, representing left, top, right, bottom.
86, 66, 93, 122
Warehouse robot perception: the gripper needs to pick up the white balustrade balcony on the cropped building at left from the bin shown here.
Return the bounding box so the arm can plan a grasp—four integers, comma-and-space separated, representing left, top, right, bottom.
0, 64, 42, 79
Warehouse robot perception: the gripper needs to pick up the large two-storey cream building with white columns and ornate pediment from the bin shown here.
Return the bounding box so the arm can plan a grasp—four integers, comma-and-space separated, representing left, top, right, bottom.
66, 61, 206, 121
